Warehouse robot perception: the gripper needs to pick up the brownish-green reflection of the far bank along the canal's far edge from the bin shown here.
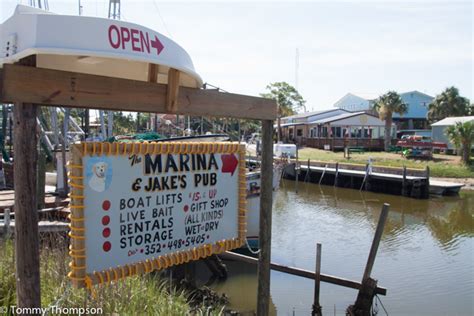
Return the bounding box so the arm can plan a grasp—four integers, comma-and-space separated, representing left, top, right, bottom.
284, 180, 474, 250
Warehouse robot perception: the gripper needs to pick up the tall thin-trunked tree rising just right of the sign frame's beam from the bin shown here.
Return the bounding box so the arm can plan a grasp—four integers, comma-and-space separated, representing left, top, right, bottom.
260, 82, 306, 141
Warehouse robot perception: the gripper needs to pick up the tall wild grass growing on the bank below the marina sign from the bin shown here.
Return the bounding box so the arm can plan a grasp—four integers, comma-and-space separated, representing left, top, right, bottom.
0, 235, 227, 315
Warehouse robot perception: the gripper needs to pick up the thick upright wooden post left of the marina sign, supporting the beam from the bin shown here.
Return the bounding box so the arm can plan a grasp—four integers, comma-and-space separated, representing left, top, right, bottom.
13, 103, 41, 308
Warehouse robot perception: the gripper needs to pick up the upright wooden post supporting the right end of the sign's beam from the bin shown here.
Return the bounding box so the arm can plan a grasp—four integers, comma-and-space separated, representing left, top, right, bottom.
257, 120, 273, 316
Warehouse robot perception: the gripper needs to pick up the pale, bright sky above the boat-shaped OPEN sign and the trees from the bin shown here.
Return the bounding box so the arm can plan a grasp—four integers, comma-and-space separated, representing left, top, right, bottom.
0, 0, 474, 110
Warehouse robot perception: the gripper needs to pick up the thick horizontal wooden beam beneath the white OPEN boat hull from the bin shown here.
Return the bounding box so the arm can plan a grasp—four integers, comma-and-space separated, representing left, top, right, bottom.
0, 64, 277, 120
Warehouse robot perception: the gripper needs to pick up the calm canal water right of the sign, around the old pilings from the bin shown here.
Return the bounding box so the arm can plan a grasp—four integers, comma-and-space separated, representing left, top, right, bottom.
201, 180, 474, 315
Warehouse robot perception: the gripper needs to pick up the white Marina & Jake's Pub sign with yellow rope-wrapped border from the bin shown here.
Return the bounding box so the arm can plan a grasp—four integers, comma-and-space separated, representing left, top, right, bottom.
69, 142, 246, 287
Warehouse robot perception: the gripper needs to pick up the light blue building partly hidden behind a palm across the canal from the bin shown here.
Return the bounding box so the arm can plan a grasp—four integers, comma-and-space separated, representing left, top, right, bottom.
334, 90, 434, 130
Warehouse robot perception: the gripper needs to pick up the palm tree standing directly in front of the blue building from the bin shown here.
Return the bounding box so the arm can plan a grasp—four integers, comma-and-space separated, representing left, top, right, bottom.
373, 91, 408, 151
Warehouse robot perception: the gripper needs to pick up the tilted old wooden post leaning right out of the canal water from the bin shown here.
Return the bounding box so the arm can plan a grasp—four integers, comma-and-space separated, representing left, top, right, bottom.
348, 203, 390, 316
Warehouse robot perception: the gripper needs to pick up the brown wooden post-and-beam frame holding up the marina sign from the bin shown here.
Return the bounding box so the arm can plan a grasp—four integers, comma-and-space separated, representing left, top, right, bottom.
0, 56, 277, 315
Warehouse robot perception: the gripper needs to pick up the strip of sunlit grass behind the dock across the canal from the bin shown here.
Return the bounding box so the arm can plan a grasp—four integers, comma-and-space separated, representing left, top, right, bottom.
298, 148, 474, 178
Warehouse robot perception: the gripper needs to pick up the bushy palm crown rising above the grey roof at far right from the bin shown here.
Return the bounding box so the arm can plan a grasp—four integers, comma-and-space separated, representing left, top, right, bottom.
427, 87, 472, 122
